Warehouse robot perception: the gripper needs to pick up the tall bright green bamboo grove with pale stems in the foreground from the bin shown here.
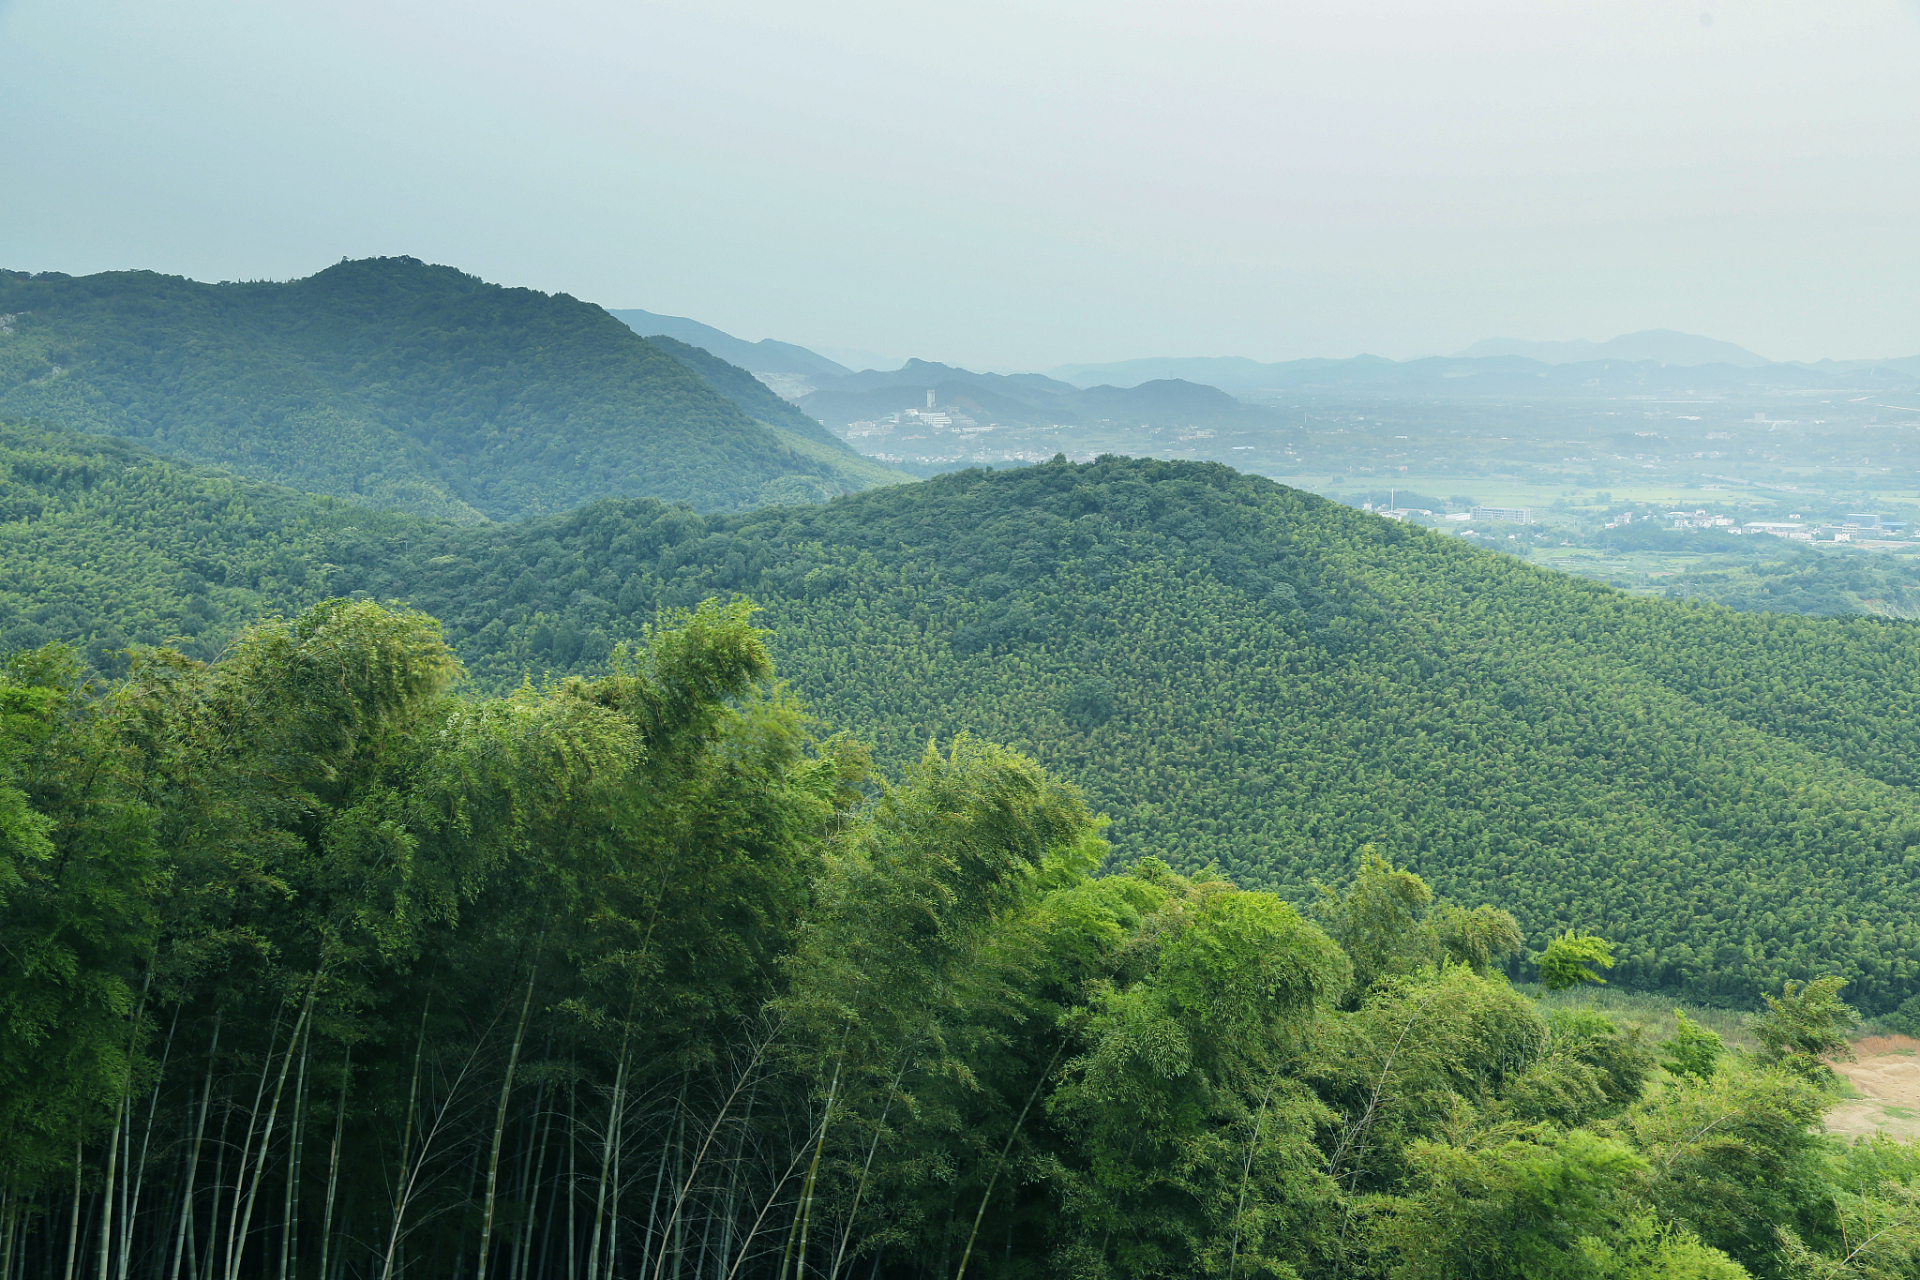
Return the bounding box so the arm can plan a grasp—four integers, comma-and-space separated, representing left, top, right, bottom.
0, 599, 1920, 1280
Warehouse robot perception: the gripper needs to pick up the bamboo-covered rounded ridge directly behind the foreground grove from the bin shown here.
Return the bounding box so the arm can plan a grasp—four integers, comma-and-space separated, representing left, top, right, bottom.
11, 430, 1920, 1013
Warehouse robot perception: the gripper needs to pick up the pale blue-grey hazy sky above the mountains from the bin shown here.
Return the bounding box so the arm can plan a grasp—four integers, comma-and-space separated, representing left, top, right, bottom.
0, 0, 1920, 368
